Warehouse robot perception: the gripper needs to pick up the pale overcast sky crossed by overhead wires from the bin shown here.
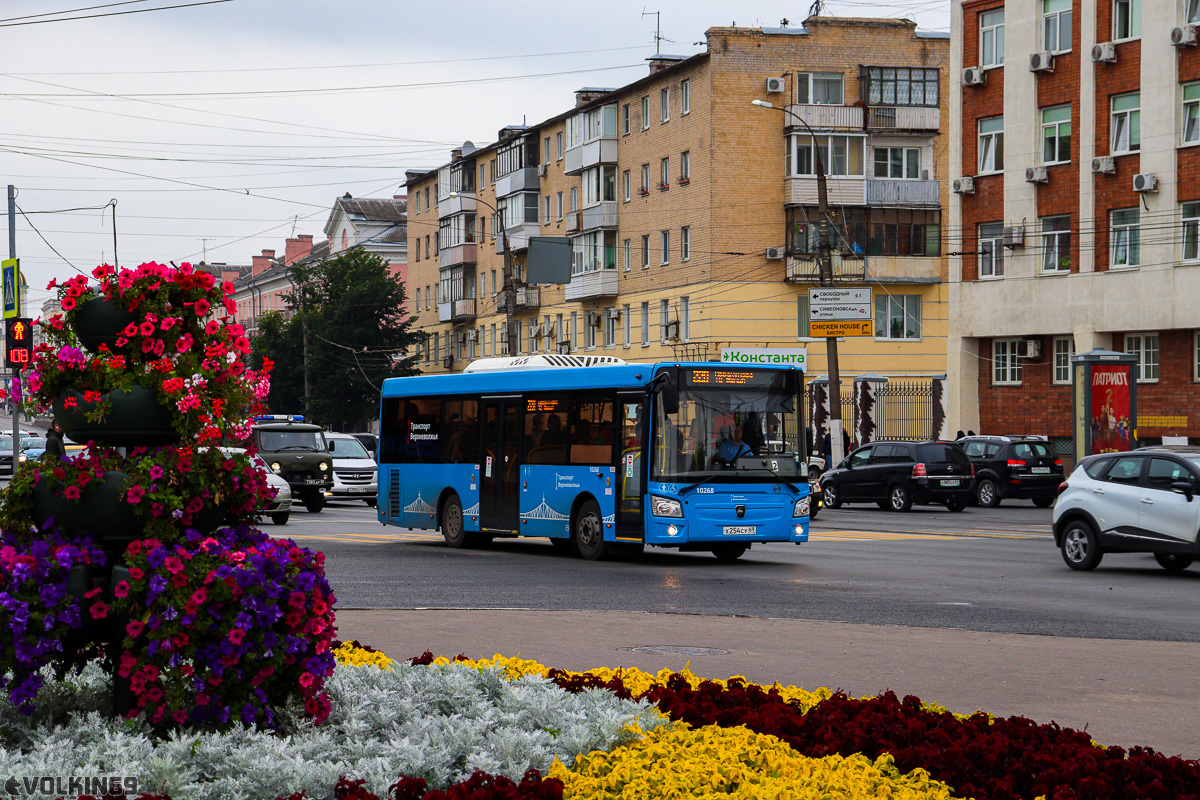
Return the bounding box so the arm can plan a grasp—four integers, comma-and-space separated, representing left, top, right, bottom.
0, 0, 949, 315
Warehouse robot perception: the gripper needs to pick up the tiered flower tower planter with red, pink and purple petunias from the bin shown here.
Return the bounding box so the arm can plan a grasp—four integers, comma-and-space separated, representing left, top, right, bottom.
0, 264, 334, 729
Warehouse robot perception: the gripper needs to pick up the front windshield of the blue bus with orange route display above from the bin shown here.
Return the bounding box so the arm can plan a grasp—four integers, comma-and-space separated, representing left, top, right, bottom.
650, 366, 802, 481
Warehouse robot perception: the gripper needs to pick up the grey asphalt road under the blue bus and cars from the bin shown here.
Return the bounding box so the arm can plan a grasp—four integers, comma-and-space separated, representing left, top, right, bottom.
266, 501, 1200, 642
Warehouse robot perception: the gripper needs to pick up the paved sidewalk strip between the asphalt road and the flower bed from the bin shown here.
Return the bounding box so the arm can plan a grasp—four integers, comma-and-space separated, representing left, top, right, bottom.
337, 609, 1200, 758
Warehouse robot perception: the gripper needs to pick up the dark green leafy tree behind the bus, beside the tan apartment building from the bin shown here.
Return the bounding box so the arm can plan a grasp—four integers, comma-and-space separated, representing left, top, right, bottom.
253, 248, 421, 429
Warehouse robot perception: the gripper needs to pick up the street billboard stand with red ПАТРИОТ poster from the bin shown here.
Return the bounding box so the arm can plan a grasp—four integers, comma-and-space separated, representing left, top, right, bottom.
1070, 350, 1138, 464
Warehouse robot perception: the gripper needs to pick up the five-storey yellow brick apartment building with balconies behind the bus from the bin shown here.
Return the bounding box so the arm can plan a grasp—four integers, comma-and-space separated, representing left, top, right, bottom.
407, 17, 949, 398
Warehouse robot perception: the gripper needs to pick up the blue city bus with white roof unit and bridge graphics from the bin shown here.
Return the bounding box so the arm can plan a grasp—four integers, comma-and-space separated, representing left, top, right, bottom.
378, 355, 809, 560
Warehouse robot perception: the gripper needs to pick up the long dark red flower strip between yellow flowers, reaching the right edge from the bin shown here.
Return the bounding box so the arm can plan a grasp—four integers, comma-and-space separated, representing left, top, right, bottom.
550, 669, 1200, 800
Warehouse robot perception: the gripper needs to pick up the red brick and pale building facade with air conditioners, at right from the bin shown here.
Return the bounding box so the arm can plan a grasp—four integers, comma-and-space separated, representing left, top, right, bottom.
948, 0, 1200, 443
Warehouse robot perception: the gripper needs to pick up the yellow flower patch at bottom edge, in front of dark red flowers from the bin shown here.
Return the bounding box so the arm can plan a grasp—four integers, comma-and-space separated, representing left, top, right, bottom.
548, 723, 953, 800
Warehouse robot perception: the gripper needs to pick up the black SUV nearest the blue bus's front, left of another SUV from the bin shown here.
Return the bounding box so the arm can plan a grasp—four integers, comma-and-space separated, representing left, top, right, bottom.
821, 441, 974, 511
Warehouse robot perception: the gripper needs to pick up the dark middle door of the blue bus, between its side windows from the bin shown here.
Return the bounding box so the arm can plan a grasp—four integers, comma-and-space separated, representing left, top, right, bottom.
479, 397, 521, 534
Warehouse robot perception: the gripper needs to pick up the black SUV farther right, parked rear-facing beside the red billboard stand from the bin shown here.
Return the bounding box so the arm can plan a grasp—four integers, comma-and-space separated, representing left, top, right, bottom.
959, 437, 1063, 509
